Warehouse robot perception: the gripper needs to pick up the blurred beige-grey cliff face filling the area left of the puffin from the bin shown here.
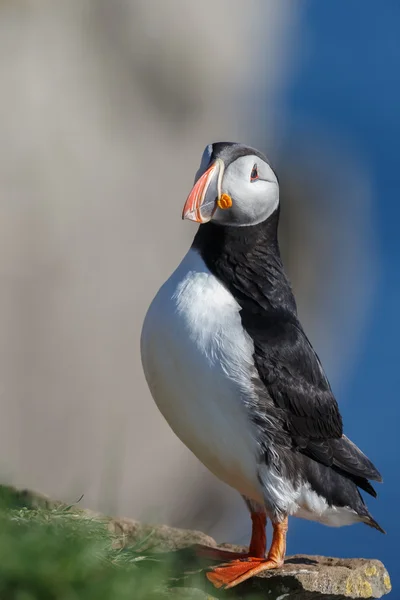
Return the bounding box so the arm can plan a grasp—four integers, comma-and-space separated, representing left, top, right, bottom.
0, 0, 291, 544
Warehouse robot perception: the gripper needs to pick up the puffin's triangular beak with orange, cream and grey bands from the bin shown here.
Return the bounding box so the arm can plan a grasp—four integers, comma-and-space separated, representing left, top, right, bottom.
182, 158, 224, 223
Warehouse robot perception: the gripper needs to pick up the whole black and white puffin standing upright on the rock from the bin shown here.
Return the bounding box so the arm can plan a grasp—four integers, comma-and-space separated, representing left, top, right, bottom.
141, 142, 385, 588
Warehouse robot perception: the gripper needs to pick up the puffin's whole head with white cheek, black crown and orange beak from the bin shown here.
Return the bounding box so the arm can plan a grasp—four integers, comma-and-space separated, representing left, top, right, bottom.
182, 142, 279, 227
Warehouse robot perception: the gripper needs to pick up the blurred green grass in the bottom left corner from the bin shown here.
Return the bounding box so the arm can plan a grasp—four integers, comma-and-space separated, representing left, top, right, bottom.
0, 490, 181, 600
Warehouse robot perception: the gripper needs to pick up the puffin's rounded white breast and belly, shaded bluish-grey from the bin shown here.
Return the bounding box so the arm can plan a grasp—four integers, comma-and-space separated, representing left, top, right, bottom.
141, 250, 262, 502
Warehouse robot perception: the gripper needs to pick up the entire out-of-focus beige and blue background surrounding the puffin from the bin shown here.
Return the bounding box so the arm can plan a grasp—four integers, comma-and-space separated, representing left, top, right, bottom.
0, 0, 400, 583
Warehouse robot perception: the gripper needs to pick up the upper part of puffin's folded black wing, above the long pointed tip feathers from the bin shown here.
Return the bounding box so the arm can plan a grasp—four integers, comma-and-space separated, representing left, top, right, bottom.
241, 311, 343, 446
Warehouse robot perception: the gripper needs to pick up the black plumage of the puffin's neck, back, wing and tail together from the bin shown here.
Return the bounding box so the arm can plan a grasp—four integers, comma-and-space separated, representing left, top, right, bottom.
193, 208, 381, 529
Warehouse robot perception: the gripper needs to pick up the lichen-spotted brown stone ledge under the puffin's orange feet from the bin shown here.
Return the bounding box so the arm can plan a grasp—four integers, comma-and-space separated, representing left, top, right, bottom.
1, 486, 391, 600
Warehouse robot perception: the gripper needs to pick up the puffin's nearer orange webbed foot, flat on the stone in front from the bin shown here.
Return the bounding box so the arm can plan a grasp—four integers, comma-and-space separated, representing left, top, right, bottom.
206, 558, 283, 590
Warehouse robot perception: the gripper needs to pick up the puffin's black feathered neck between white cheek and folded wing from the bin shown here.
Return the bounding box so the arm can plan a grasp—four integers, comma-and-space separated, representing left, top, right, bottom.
192, 210, 296, 315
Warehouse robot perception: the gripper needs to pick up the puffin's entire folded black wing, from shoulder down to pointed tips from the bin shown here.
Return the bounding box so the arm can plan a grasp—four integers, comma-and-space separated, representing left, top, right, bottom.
241, 311, 381, 488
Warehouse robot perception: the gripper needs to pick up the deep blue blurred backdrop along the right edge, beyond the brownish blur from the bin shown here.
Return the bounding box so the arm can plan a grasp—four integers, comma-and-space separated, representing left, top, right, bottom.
284, 0, 400, 588
